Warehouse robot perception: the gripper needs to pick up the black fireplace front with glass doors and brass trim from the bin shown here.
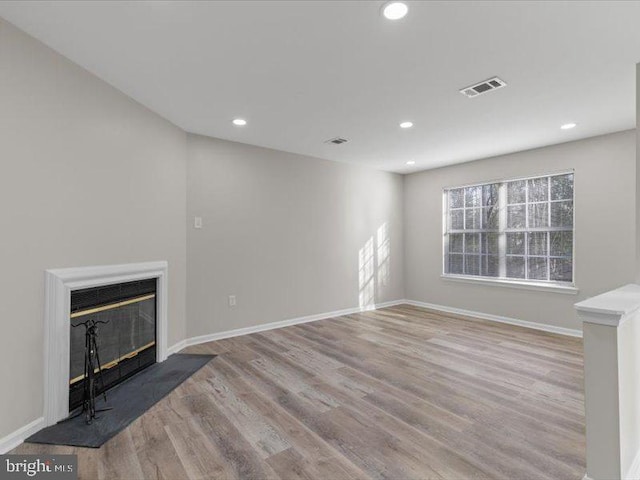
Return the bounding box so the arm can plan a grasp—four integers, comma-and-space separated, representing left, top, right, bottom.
69, 279, 156, 411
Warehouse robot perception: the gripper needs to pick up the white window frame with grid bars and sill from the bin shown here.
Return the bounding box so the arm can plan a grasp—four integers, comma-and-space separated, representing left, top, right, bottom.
441, 169, 579, 294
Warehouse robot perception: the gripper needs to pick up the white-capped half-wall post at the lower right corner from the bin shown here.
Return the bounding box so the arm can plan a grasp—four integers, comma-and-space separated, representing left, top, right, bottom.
575, 285, 640, 480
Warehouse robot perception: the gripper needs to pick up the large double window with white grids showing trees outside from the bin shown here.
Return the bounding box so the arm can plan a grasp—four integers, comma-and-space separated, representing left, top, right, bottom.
444, 173, 573, 284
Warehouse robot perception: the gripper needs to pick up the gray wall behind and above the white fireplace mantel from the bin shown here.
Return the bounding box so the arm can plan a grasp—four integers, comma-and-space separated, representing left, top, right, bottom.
0, 20, 186, 438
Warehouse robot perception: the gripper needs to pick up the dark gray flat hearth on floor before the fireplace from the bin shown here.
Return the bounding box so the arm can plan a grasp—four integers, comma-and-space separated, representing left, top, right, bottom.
25, 354, 215, 448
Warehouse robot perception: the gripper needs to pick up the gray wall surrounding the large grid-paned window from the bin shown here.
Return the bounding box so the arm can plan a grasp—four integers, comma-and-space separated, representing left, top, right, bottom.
404, 130, 636, 329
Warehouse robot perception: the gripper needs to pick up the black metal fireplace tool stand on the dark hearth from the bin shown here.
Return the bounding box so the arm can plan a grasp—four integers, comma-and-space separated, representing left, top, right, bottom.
68, 319, 112, 425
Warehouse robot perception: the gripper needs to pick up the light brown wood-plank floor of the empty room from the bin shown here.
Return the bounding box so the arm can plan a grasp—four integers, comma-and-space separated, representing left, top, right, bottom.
12, 306, 585, 480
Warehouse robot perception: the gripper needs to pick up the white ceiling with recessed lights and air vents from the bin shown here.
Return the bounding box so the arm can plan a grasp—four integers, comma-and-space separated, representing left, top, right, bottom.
0, 1, 640, 172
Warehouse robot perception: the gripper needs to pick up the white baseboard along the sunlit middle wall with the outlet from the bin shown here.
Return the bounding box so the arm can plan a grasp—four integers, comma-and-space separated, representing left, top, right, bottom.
168, 300, 407, 355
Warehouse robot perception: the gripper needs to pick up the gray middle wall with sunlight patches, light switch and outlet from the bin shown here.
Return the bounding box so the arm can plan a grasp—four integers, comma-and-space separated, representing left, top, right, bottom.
187, 135, 404, 337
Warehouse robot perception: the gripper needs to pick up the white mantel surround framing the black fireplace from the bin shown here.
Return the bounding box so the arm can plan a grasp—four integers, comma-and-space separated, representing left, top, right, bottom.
44, 261, 168, 426
